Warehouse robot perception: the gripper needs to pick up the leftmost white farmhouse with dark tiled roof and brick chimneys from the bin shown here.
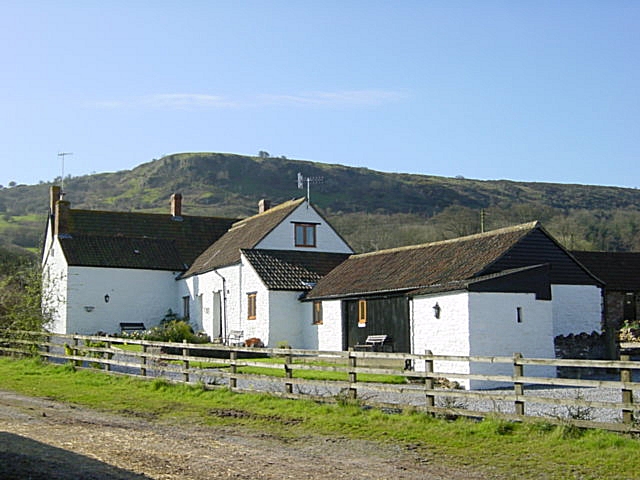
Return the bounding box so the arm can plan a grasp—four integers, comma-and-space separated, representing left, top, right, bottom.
42, 187, 236, 334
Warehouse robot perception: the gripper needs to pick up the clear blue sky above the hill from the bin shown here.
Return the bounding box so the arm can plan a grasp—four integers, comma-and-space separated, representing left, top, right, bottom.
0, 0, 640, 187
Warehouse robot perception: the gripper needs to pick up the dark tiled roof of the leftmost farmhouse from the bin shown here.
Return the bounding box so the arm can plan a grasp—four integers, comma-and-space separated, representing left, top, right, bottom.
60, 210, 237, 271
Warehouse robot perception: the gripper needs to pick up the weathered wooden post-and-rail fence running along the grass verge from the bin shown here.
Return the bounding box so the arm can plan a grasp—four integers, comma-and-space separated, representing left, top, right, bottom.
0, 332, 640, 432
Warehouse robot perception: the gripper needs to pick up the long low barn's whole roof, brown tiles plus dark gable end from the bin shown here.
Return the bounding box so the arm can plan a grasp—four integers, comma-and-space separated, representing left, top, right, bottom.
308, 222, 600, 298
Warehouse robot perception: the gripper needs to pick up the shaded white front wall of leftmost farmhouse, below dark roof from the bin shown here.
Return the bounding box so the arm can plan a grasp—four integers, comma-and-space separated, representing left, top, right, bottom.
66, 267, 178, 335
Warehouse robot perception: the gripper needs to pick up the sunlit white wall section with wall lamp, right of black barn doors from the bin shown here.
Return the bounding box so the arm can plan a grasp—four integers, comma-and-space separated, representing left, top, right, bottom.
410, 292, 471, 385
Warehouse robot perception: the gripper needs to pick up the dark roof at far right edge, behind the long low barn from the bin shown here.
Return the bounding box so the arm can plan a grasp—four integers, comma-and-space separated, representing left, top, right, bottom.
571, 251, 640, 291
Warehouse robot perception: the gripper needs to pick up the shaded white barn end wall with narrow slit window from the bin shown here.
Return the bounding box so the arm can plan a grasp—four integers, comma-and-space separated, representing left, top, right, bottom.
469, 293, 555, 388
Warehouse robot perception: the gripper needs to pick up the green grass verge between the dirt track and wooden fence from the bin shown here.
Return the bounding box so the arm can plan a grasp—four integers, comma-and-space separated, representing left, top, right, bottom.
0, 358, 640, 479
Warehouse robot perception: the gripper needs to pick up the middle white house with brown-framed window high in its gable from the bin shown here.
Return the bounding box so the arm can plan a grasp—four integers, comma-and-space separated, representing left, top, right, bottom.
179, 198, 353, 348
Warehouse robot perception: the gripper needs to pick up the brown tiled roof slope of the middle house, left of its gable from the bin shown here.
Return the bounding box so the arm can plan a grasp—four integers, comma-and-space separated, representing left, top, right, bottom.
185, 198, 305, 277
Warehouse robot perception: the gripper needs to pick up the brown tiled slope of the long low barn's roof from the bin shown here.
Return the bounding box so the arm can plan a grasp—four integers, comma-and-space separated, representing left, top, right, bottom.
307, 222, 552, 299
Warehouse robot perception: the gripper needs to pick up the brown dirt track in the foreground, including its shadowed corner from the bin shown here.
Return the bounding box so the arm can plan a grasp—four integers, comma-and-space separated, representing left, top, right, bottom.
0, 391, 491, 480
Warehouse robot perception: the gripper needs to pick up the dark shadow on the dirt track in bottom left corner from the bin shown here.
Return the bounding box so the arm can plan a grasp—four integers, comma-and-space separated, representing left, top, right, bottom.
0, 432, 150, 480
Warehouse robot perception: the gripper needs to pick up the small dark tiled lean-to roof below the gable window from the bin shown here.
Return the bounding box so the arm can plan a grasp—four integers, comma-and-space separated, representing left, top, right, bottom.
242, 249, 349, 291
